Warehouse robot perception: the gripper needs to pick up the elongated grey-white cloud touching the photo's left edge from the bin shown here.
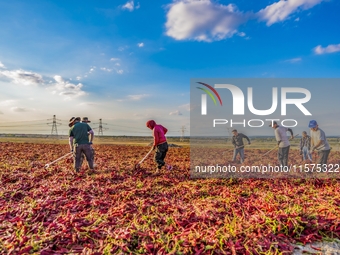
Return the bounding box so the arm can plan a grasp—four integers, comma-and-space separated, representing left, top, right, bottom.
0, 70, 44, 86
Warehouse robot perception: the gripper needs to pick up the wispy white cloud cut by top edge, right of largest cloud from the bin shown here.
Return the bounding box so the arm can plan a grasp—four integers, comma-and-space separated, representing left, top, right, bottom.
257, 0, 323, 26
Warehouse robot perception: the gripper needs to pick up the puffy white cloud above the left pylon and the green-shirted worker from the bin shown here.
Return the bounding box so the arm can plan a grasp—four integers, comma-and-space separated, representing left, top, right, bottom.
50, 75, 86, 100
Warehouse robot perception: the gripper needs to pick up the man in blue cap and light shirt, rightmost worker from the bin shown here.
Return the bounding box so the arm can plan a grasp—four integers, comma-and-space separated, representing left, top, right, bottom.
308, 120, 331, 164
